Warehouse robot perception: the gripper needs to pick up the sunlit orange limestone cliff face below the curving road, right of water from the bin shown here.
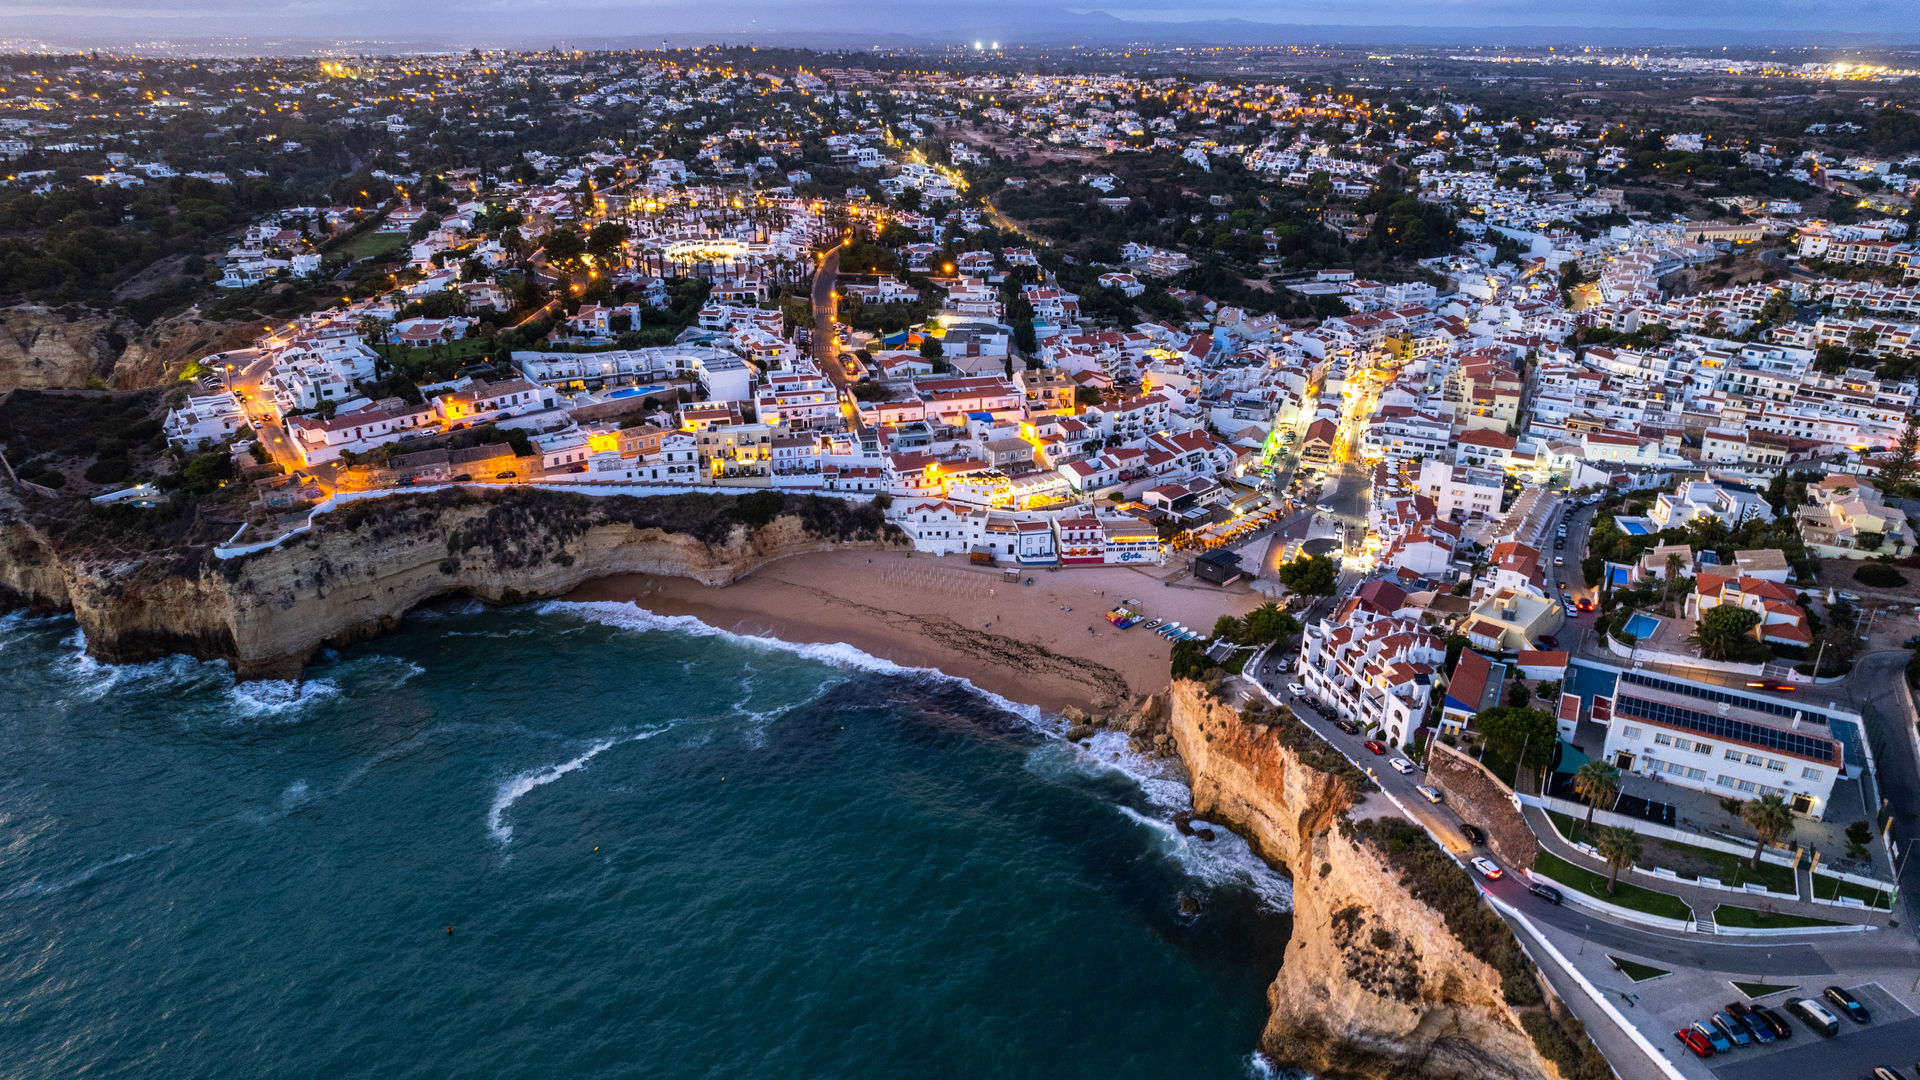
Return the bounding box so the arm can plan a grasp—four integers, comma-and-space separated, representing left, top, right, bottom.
1169, 682, 1555, 1080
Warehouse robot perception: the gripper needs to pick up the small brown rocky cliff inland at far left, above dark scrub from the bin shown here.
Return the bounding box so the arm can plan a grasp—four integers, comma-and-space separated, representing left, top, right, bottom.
0, 306, 259, 394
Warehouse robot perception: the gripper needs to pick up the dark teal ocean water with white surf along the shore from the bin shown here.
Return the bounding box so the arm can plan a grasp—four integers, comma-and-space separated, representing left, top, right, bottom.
0, 603, 1290, 1080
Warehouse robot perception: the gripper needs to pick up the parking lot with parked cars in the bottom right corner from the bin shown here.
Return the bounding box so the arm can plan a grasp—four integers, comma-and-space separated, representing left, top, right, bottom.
1705, 982, 1920, 1080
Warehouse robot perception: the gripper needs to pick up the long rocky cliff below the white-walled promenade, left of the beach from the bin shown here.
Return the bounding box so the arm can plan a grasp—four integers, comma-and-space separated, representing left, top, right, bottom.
0, 488, 898, 678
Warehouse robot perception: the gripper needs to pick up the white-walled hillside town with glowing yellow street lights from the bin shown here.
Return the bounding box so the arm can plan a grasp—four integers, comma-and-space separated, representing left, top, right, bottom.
0, 42, 1920, 1080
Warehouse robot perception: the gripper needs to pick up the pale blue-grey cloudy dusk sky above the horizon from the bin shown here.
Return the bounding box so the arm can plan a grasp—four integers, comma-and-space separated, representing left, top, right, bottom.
0, 0, 1920, 46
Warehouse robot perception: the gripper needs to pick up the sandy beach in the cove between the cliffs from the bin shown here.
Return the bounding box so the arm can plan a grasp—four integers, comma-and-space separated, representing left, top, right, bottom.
566, 552, 1263, 711
